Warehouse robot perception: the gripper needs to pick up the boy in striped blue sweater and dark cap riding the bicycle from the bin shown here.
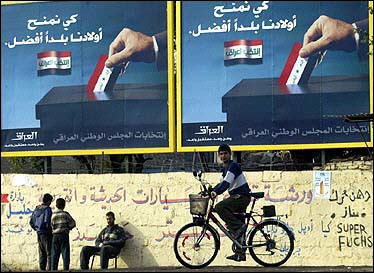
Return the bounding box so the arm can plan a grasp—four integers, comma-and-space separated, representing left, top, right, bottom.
211, 144, 251, 262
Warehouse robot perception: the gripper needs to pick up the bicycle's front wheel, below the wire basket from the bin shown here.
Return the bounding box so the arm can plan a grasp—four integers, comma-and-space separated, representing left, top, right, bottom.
174, 223, 219, 269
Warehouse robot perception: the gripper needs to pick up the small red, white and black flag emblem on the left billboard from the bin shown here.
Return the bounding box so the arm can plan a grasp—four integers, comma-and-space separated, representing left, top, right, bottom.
37, 51, 71, 76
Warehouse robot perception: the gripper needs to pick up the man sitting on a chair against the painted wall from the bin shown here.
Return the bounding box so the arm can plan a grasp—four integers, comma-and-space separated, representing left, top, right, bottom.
80, 211, 132, 269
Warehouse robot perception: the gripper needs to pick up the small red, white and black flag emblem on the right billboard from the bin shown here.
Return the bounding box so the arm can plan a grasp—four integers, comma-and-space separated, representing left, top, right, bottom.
223, 40, 262, 66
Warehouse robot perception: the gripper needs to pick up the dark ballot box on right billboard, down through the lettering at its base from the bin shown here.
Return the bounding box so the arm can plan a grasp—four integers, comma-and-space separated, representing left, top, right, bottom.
222, 75, 370, 144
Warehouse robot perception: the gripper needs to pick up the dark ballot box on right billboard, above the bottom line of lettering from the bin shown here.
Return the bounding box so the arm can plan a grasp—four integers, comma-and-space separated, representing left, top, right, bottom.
222, 75, 370, 125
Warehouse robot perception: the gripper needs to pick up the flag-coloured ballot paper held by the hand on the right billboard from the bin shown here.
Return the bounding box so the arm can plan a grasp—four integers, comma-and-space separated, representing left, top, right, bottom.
278, 43, 322, 85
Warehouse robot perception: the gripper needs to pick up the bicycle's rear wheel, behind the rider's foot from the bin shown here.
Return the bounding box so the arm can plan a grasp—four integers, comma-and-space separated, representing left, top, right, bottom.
248, 220, 294, 266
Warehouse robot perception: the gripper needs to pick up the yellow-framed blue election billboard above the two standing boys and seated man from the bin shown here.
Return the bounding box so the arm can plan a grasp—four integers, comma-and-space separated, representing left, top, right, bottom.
1, 1, 175, 156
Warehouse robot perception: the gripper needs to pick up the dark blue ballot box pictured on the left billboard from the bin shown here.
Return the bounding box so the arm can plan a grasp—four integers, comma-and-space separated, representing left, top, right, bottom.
36, 84, 168, 132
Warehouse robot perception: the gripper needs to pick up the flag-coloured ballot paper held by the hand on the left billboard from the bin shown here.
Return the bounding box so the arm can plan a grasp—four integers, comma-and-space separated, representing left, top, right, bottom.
87, 54, 129, 92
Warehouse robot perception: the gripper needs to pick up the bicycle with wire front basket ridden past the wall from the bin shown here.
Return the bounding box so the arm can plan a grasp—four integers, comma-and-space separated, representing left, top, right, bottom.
174, 171, 295, 269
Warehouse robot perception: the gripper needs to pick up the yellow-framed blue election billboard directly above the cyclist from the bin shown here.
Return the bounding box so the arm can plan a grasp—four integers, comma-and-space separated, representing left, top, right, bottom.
176, 1, 373, 152
